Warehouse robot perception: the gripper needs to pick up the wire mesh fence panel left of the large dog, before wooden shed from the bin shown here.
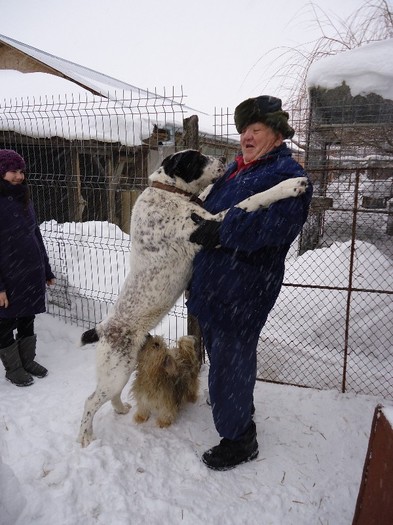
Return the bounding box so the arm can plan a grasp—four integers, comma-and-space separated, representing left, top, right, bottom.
0, 86, 185, 333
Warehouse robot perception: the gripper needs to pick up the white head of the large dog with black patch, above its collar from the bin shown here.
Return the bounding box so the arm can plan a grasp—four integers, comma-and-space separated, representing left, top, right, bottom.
149, 149, 224, 195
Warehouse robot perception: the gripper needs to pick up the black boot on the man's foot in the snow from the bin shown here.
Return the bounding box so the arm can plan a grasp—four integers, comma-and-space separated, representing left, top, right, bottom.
202, 421, 259, 470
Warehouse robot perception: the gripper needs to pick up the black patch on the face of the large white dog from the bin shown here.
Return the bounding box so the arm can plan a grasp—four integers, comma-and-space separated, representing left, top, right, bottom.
161, 150, 208, 182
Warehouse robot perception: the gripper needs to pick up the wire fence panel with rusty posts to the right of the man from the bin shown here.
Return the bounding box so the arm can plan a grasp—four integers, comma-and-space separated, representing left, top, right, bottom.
258, 93, 393, 398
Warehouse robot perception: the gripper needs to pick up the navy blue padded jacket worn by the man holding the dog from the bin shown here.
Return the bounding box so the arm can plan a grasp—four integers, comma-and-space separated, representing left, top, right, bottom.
187, 144, 312, 328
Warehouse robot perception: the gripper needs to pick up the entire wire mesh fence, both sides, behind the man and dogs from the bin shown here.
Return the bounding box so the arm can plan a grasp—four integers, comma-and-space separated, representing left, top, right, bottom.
0, 92, 393, 398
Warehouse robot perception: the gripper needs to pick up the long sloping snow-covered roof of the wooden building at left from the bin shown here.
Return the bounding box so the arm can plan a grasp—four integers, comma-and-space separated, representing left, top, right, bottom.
0, 35, 208, 146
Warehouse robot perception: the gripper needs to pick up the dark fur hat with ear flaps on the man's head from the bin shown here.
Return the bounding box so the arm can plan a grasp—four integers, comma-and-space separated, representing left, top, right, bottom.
235, 95, 295, 139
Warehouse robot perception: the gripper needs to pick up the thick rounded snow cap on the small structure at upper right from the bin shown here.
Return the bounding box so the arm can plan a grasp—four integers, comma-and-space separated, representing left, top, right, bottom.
307, 39, 393, 100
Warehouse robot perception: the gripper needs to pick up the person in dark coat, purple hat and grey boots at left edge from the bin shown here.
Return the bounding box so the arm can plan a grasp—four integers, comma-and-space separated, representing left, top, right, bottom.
0, 149, 55, 386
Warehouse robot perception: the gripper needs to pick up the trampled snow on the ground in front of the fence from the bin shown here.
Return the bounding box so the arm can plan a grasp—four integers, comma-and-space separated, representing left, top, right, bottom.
0, 314, 389, 525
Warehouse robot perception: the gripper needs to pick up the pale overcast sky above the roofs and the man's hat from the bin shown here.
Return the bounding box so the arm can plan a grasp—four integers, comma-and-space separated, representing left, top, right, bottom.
0, 0, 391, 113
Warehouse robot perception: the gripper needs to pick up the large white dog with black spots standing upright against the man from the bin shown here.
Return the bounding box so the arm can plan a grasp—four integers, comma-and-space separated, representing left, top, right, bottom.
78, 150, 307, 446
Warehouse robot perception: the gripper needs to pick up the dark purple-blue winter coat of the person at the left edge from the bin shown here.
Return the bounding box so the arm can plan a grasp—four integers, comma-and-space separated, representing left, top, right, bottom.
0, 180, 54, 319
